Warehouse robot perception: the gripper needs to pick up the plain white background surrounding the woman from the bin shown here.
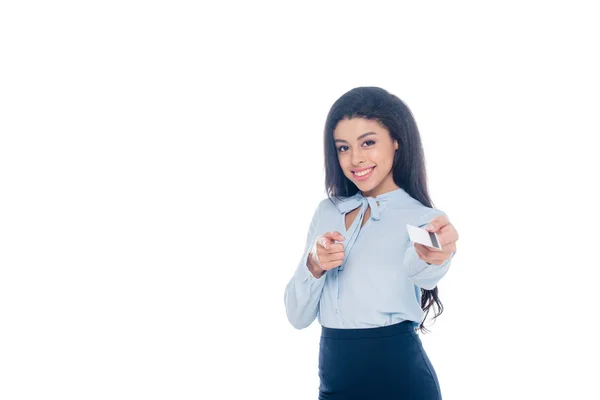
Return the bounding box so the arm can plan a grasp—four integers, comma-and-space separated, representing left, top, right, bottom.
0, 1, 600, 400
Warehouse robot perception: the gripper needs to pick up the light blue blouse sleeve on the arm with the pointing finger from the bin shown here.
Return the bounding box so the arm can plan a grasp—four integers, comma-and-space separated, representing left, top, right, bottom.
284, 202, 327, 329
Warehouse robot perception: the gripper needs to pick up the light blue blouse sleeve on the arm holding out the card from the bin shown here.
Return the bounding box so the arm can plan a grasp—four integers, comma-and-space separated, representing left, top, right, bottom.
404, 210, 456, 290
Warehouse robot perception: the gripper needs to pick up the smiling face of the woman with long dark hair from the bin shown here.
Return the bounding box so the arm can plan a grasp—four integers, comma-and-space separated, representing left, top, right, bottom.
333, 118, 398, 197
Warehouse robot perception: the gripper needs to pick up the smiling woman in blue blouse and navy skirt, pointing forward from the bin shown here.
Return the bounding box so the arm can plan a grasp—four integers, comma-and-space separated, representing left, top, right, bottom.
285, 87, 458, 400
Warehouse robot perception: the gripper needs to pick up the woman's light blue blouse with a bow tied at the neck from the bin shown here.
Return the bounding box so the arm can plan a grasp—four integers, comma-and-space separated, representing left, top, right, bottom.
284, 188, 454, 329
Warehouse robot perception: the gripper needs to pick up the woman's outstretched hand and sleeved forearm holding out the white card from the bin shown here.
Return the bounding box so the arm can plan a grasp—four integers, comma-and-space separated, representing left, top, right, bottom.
404, 213, 458, 290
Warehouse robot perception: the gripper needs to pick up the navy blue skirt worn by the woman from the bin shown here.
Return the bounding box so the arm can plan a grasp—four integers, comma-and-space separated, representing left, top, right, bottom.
319, 321, 442, 400
